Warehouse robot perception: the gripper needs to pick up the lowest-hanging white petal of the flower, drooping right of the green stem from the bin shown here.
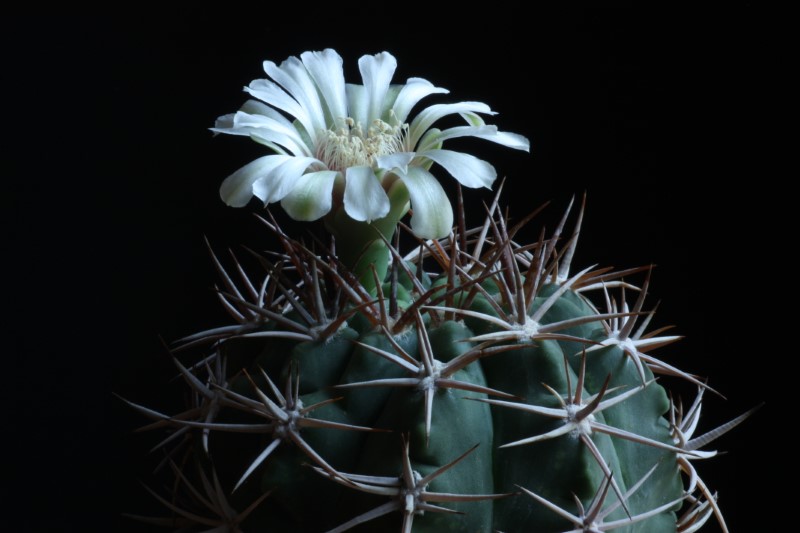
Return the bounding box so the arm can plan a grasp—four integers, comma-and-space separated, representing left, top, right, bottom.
398, 167, 453, 239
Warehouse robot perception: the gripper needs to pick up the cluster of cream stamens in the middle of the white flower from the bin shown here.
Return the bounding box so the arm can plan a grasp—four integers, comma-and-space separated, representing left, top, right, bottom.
317, 117, 408, 172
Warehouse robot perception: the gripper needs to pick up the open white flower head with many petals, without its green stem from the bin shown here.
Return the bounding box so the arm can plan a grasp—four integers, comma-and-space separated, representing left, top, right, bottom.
212, 49, 529, 238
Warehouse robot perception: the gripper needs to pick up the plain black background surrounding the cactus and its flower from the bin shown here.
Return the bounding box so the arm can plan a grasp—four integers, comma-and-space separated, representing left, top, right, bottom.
6, 10, 780, 531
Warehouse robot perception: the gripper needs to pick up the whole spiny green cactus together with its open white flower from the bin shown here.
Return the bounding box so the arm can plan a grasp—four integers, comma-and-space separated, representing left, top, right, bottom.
123, 50, 749, 532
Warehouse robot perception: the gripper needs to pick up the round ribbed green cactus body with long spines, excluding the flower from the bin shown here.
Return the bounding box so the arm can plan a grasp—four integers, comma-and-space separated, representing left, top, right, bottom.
125, 197, 736, 533
